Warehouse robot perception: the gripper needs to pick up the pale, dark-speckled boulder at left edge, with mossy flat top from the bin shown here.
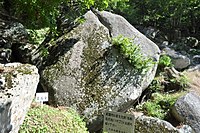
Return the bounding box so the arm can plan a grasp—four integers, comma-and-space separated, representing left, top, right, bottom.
0, 63, 39, 133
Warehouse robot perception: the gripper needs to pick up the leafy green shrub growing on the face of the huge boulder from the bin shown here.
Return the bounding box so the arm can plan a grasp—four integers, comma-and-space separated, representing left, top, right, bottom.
112, 36, 155, 73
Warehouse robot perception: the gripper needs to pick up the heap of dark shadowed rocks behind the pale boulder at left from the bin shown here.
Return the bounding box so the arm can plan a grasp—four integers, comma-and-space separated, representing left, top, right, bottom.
0, 9, 38, 66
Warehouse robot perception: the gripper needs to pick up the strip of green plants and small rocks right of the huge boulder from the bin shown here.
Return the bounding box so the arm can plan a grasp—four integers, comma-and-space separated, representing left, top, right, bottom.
136, 55, 188, 119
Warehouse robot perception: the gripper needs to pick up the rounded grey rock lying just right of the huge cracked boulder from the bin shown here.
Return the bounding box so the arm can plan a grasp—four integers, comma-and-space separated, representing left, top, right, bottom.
163, 48, 190, 69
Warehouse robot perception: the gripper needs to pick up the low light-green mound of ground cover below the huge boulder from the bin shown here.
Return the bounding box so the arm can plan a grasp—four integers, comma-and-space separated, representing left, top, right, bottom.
19, 103, 88, 133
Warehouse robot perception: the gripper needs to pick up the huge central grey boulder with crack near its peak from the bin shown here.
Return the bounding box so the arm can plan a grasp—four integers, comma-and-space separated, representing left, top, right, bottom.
41, 11, 160, 131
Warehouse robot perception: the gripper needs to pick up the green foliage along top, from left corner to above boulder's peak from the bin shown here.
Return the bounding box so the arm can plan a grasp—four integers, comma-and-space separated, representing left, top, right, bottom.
0, 0, 127, 29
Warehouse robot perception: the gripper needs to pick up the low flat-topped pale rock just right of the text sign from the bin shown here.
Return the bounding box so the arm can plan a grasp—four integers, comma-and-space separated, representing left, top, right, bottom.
135, 116, 193, 133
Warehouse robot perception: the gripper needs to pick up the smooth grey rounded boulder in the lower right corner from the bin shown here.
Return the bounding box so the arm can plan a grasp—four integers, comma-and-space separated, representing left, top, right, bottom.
172, 92, 200, 133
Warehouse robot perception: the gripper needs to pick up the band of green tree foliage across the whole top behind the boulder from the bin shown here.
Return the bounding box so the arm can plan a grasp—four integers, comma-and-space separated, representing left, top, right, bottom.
0, 0, 200, 39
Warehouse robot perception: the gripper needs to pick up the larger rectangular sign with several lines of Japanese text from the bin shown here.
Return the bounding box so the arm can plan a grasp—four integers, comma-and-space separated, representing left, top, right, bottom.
103, 111, 135, 133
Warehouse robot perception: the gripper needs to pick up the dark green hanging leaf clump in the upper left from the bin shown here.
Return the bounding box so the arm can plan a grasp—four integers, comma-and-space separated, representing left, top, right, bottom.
9, 0, 63, 28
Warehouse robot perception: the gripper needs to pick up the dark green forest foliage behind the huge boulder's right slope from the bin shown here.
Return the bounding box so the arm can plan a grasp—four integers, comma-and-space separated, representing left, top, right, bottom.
112, 0, 200, 39
